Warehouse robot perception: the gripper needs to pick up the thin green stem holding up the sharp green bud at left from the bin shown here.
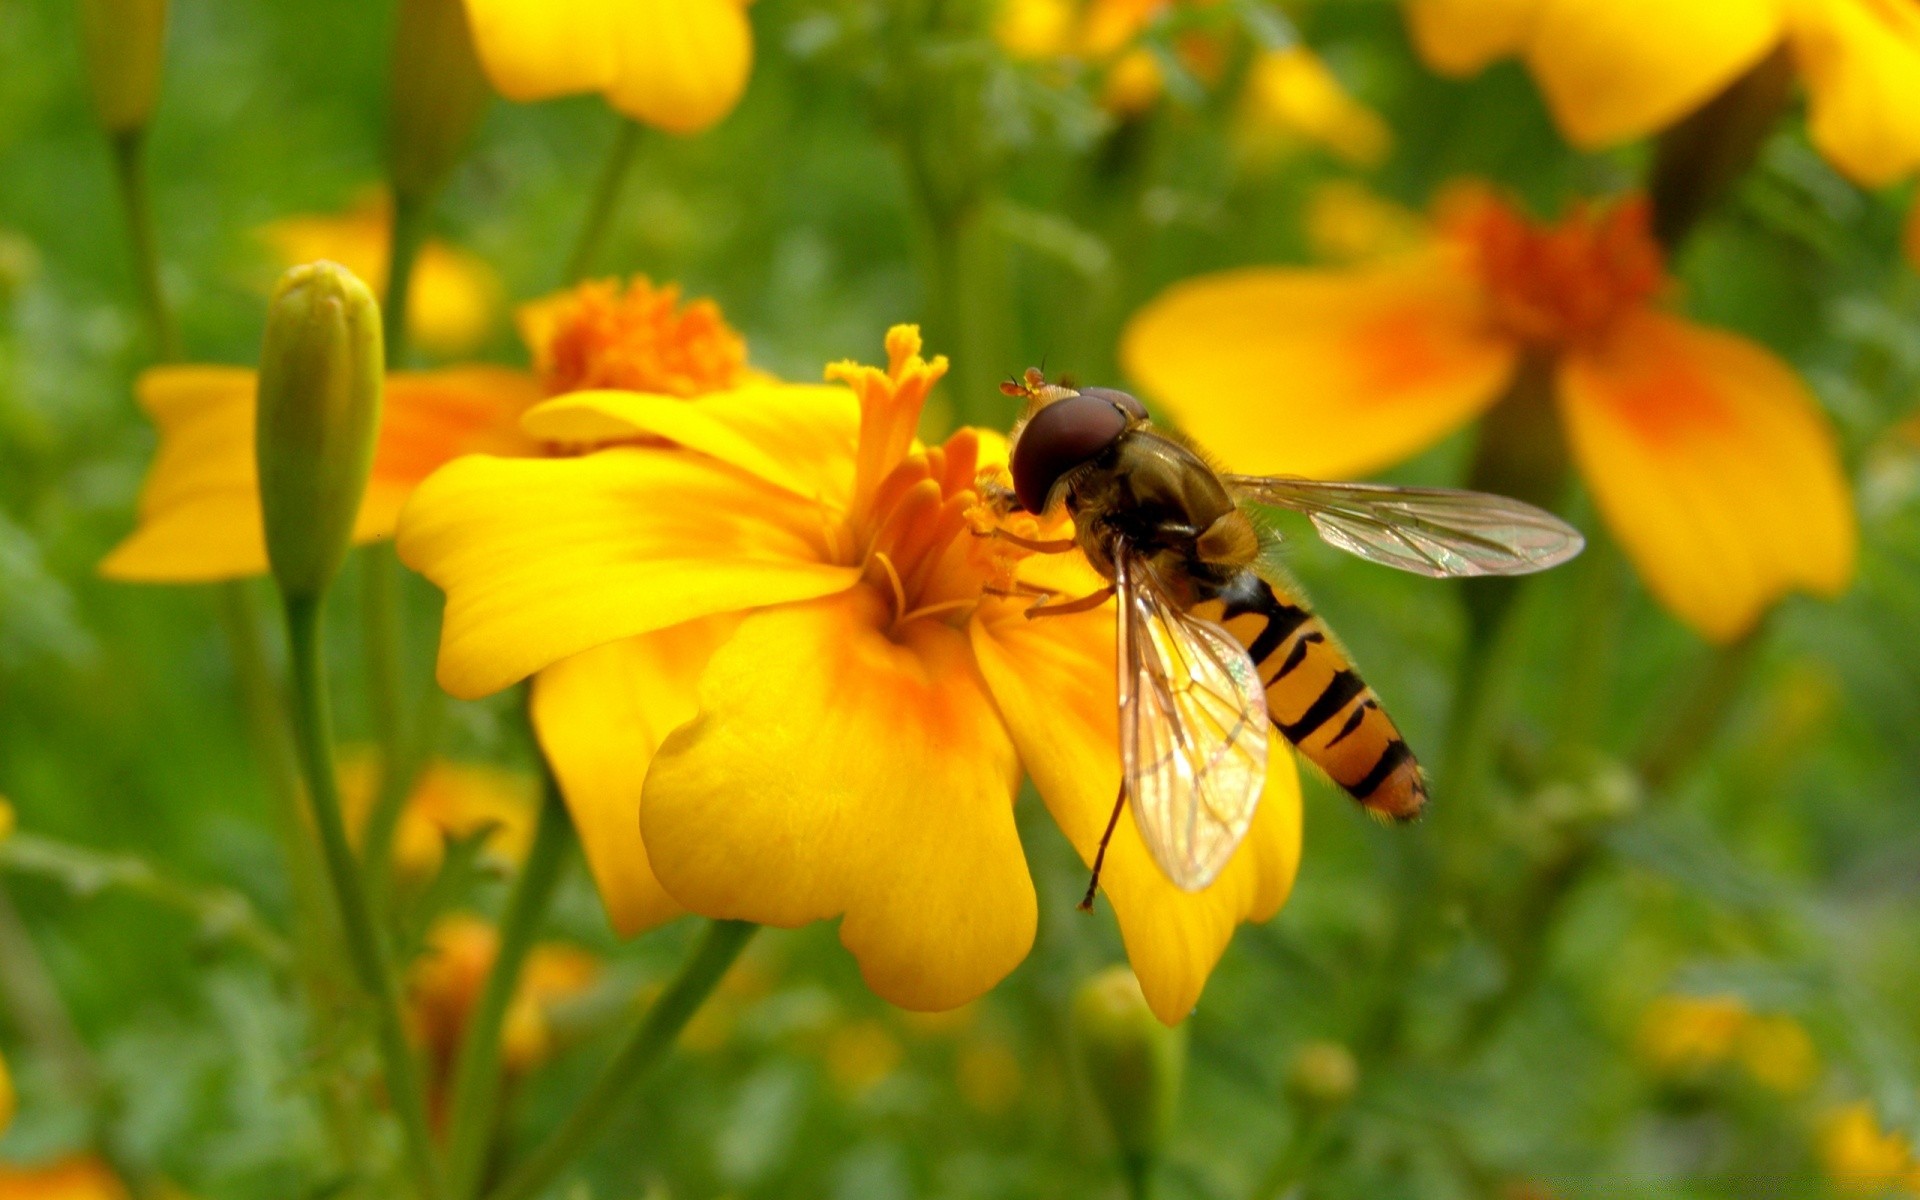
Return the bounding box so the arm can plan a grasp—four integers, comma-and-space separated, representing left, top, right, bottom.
286, 597, 444, 1200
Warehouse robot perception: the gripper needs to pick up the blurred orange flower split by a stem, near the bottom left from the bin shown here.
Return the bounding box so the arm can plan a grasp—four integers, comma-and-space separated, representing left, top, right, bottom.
407, 912, 599, 1110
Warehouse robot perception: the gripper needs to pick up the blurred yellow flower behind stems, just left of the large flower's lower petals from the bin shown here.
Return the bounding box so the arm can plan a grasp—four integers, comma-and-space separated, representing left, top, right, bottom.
340, 749, 538, 879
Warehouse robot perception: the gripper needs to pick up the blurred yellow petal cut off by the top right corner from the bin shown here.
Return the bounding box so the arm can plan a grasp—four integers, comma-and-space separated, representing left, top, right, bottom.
1793, 0, 1920, 188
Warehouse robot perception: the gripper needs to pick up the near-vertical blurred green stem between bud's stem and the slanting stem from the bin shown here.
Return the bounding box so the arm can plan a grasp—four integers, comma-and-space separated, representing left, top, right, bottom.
447, 774, 568, 1200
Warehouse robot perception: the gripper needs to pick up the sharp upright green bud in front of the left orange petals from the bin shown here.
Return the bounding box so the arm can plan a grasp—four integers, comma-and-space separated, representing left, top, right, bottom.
253, 263, 384, 599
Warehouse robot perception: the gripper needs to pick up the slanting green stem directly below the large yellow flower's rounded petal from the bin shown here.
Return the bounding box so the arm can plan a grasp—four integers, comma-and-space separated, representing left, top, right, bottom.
488, 920, 758, 1200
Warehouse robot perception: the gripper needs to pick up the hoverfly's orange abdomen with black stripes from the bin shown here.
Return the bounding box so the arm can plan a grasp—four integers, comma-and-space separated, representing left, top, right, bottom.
1192, 570, 1427, 820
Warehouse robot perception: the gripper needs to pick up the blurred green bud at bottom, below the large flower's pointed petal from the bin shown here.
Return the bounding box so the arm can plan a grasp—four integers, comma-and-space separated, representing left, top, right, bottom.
1073, 966, 1187, 1181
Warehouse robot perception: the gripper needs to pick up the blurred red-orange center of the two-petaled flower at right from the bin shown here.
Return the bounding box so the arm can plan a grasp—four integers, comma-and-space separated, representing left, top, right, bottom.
1440, 188, 1667, 348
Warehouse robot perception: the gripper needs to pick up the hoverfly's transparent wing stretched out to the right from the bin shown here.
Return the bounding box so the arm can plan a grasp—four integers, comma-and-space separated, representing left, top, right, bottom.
1223, 474, 1586, 578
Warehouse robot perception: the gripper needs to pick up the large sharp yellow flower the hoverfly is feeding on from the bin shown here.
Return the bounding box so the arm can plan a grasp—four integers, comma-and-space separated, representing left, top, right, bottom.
399, 326, 1300, 1021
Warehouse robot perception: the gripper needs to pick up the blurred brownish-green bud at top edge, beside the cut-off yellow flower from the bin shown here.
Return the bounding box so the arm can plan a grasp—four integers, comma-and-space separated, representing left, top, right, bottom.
388, 0, 492, 198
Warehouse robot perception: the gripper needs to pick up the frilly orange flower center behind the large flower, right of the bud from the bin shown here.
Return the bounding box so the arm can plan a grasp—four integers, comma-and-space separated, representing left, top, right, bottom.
522, 276, 747, 396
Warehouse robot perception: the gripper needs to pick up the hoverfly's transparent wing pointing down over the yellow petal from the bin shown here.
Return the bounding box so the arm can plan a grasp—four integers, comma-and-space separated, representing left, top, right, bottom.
1114, 545, 1267, 891
